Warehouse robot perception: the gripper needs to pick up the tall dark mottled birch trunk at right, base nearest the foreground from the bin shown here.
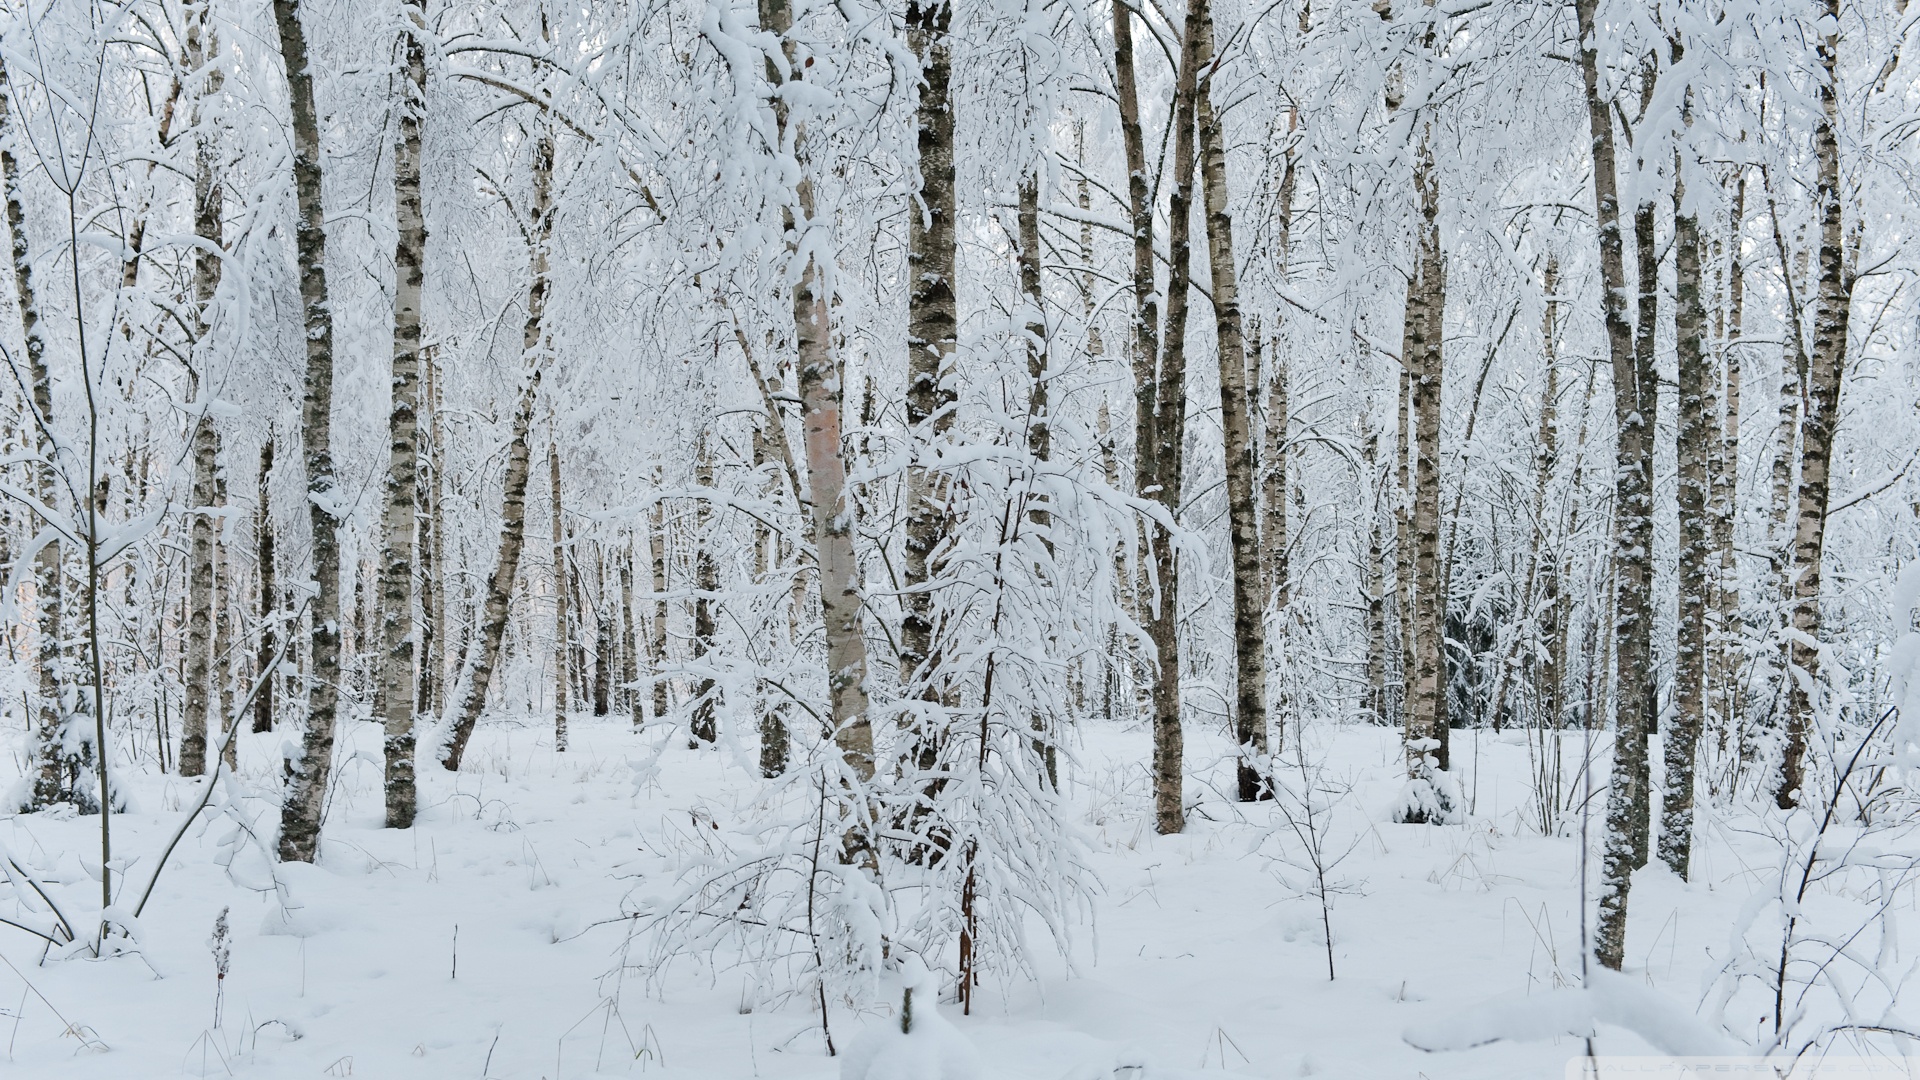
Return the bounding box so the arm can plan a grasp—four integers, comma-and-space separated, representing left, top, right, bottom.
1574, 0, 1653, 970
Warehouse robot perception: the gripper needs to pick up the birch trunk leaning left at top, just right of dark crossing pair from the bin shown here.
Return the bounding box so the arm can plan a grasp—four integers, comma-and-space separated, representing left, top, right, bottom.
1187, 0, 1284, 803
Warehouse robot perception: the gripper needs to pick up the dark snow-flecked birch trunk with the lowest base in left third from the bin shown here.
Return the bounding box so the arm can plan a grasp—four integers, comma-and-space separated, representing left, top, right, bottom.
273, 0, 340, 863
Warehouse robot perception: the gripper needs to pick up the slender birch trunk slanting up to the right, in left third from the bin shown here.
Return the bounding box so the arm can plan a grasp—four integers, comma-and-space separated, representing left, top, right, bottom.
444, 107, 564, 773
